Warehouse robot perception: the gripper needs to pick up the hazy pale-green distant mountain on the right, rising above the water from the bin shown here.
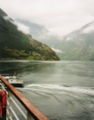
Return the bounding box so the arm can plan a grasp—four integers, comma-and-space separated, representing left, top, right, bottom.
60, 22, 94, 60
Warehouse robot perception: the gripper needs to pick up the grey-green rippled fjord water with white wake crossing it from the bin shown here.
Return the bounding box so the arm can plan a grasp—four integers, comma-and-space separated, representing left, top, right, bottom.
0, 60, 94, 120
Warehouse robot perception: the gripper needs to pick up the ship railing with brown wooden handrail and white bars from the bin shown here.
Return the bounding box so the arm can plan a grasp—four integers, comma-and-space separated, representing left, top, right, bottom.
0, 76, 49, 120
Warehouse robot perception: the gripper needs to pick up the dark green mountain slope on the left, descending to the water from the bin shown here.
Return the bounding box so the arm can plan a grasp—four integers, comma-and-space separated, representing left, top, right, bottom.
0, 9, 59, 60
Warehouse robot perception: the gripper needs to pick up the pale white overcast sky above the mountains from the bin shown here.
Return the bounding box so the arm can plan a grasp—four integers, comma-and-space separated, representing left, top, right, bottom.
0, 0, 94, 36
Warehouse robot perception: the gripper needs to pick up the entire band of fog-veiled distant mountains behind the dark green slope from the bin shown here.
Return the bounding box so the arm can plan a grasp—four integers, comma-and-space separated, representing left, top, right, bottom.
16, 20, 94, 60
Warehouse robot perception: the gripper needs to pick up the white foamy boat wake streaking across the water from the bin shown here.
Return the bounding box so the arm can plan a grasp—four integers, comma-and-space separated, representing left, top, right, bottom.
25, 84, 94, 95
